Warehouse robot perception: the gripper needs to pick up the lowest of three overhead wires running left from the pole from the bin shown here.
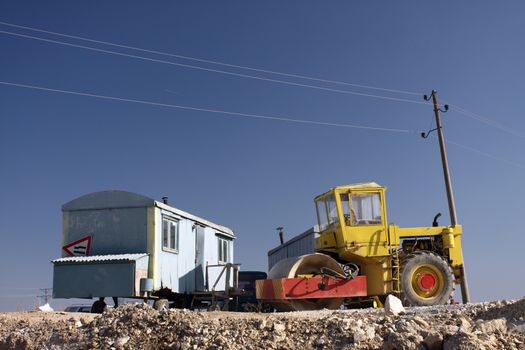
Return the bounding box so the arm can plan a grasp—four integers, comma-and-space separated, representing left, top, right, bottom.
0, 81, 416, 133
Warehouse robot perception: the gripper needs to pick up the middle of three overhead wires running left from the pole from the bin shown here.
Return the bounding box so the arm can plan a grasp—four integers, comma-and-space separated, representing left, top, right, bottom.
0, 30, 426, 105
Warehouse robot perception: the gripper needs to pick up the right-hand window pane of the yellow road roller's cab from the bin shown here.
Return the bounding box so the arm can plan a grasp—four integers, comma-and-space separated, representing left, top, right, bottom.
349, 193, 382, 225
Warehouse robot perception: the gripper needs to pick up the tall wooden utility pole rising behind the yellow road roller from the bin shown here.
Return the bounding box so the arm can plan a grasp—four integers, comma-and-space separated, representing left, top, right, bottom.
421, 90, 470, 304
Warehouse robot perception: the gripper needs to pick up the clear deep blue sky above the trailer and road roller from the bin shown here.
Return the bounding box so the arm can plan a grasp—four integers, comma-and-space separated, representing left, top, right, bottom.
0, 1, 525, 310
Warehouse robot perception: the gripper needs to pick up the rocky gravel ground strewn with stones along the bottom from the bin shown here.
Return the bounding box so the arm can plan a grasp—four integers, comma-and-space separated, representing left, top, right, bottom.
0, 299, 525, 350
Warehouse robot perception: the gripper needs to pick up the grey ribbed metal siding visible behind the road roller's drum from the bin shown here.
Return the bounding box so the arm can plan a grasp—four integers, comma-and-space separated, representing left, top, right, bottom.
268, 228, 316, 271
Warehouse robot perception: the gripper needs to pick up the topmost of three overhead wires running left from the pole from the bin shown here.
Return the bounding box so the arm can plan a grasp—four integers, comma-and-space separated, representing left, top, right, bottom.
0, 21, 422, 96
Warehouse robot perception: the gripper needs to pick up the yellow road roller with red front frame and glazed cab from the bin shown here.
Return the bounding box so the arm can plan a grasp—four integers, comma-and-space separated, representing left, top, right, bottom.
256, 182, 465, 310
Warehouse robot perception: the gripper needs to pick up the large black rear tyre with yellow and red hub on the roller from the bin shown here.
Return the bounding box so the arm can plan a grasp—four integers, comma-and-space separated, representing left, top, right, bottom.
401, 252, 454, 306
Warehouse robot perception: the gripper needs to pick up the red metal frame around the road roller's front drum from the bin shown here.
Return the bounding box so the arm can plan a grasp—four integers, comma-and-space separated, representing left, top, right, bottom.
256, 276, 367, 300
